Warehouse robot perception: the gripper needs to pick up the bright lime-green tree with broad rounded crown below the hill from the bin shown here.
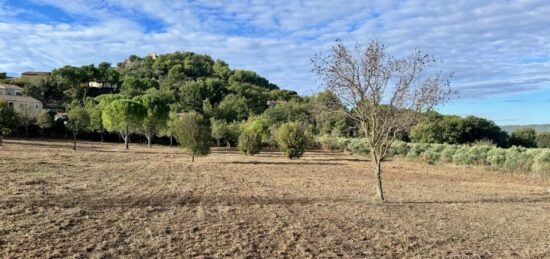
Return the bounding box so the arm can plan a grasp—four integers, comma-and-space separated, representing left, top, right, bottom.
101, 99, 147, 149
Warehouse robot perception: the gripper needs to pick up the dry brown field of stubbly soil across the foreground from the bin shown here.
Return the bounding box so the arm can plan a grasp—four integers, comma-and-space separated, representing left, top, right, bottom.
0, 140, 550, 258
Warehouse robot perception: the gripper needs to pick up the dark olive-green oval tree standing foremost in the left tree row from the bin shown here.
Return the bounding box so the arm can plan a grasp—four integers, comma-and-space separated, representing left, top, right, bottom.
174, 112, 210, 162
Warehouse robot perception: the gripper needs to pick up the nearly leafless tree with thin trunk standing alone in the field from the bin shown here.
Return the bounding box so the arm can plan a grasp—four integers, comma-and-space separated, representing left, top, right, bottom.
312, 40, 453, 201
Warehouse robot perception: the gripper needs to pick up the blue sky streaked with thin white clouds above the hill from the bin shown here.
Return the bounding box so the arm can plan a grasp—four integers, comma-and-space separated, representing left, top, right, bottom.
0, 0, 550, 125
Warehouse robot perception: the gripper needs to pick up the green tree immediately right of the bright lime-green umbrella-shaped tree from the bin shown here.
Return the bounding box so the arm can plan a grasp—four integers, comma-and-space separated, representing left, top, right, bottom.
135, 94, 170, 147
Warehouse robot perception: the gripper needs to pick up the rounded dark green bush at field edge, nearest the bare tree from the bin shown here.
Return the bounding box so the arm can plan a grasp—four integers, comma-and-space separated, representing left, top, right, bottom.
275, 122, 307, 159
